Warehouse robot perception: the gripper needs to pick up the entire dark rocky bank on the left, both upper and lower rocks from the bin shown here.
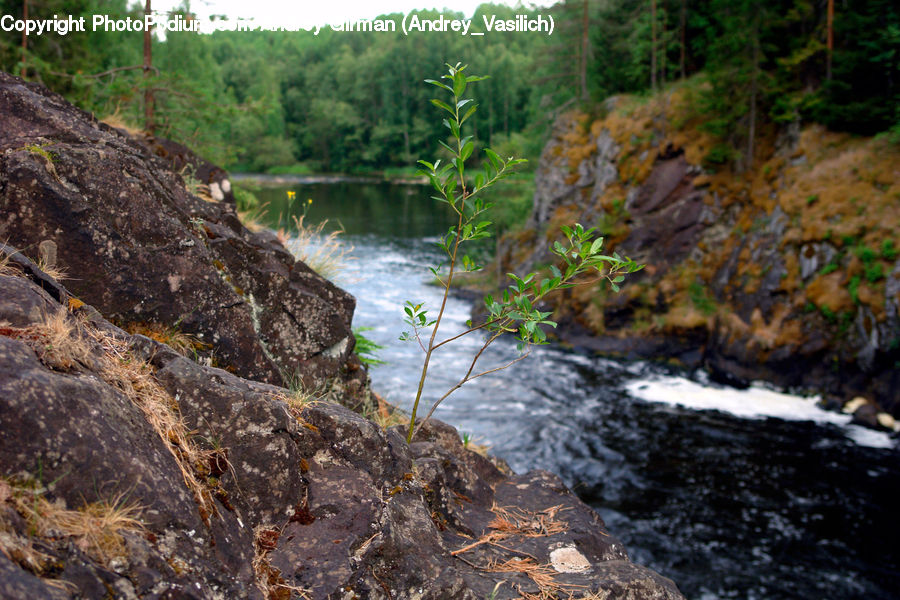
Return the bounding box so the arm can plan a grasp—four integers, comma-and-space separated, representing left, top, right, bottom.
0, 73, 682, 600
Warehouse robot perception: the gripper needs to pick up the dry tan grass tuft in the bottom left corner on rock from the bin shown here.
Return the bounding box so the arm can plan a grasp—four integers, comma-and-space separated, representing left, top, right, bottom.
0, 480, 144, 574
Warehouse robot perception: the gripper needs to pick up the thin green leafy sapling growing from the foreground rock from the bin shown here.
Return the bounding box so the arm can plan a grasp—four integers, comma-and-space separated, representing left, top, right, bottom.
400, 63, 642, 442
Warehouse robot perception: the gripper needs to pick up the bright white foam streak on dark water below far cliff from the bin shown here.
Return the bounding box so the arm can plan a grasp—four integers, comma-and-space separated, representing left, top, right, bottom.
625, 375, 894, 448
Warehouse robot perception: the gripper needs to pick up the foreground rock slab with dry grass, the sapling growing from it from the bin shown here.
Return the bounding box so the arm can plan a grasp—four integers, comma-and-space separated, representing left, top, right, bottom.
0, 247, 682, 600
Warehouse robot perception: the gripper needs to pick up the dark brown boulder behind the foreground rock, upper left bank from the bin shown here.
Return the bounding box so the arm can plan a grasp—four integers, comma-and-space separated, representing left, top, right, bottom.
0, 73, 365, 388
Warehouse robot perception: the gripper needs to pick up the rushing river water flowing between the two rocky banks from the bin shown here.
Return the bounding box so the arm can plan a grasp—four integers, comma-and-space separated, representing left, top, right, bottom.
253, 178, 900, 600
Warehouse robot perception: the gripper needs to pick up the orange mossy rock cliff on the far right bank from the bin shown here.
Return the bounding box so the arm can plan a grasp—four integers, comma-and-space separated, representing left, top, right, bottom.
501, 97, 900, 415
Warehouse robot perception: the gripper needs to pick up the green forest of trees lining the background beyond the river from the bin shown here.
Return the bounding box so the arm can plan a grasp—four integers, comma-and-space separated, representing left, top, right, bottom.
0, 0, 900, 173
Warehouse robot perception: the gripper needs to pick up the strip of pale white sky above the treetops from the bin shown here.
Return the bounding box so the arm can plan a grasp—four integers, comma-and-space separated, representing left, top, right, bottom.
153, 0, 531, 28
